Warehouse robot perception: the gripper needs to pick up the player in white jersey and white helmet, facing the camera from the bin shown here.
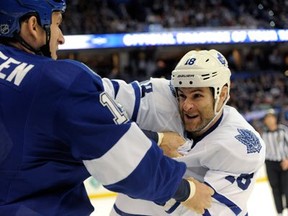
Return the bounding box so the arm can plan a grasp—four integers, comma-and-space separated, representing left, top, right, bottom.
106, 50, 265, 216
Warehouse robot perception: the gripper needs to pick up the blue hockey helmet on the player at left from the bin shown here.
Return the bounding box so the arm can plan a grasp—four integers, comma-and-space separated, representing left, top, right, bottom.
0, 0, 66, 38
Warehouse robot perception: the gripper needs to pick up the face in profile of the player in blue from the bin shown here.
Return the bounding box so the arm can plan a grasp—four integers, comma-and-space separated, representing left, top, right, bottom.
50, 12, 65, 59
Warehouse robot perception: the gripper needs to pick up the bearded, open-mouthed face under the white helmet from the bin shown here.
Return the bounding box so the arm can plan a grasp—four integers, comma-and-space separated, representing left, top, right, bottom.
178, 87, 214, 136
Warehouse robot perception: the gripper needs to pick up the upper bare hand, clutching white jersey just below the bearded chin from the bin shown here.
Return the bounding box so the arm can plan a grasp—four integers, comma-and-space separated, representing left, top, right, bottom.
158, 132, 186, 157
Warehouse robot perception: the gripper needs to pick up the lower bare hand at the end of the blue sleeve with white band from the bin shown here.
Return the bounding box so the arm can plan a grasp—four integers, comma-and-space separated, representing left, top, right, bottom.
181, 178, 214, 214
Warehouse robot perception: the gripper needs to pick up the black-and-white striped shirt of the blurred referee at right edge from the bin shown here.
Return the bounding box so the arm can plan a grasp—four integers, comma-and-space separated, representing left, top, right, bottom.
262, 124, 288, 161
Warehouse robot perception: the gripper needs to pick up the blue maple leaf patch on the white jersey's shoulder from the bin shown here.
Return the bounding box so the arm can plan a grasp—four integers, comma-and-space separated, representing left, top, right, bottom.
235, 129, 262, 154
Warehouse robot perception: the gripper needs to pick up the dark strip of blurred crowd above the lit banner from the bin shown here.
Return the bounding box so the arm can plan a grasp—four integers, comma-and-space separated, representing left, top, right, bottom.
63, 0, 288, 34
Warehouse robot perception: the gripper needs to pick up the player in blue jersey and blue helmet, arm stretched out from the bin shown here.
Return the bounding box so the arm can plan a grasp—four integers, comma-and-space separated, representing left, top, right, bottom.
0, 0, 213, 216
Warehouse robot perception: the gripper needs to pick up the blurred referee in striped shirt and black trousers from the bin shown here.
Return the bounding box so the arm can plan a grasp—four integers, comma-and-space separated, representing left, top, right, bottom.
262, 110, 288, 215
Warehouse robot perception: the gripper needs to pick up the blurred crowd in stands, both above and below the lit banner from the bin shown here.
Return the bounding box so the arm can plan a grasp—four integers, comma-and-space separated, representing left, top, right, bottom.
60, 0, 288, 130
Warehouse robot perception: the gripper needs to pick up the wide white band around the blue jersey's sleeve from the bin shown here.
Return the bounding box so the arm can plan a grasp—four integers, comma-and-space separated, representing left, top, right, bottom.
83, 123, 152, 185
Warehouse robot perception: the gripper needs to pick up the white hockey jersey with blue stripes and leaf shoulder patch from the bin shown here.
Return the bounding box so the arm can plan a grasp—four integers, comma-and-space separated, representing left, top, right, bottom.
106, 79, 265, 216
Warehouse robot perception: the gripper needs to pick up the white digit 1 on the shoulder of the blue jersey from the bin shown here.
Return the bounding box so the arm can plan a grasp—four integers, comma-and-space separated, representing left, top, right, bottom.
100, 92, 128, 124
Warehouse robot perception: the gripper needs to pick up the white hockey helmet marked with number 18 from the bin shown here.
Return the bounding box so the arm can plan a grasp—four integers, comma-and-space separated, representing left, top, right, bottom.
171, 49, 231, 114
